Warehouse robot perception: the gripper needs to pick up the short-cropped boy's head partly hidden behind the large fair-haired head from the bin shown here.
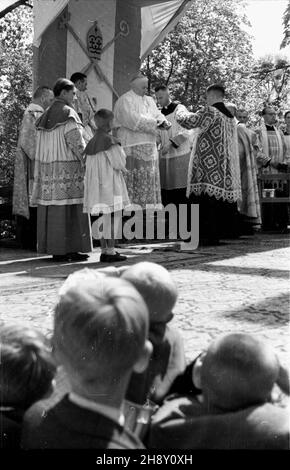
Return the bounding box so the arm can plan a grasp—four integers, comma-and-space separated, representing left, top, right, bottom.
122, 262, 177, 344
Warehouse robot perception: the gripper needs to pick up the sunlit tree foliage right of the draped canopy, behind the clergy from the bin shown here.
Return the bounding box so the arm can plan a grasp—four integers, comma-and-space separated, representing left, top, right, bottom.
142, 0, 290, 124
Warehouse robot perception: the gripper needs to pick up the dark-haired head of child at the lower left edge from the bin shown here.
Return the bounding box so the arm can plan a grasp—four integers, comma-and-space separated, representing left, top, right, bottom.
0, 324, 56, 410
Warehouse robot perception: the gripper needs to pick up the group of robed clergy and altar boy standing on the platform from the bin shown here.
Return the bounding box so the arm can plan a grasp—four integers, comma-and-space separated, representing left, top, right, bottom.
13, 72, 290, 262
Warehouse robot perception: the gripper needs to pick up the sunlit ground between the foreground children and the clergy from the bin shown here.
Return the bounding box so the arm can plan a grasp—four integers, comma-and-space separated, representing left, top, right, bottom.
0, 234, 290, 365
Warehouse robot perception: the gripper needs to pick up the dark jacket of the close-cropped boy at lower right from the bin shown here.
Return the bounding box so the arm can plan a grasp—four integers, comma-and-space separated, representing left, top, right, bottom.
147, 395, 289, 450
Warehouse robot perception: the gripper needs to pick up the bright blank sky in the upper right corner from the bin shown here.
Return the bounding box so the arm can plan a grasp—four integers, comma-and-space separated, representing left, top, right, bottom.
246, 0, 290, 59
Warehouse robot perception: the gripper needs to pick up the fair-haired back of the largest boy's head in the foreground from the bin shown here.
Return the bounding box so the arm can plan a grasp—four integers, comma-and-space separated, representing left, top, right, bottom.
53, 270, 149, 386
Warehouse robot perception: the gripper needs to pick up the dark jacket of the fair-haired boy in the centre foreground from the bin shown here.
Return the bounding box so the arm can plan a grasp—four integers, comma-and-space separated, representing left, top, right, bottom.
21, 395, 144, 449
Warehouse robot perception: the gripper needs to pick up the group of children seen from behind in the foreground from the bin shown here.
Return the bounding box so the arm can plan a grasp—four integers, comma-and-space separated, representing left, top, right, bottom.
0, 262, 290, 450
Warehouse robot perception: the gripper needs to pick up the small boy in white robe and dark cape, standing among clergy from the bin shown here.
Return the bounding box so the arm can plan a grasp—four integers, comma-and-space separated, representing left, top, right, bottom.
84, 109, 130, 263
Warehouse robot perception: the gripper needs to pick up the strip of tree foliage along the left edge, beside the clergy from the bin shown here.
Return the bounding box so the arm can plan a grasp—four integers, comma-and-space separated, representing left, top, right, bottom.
0, 6, 33, 184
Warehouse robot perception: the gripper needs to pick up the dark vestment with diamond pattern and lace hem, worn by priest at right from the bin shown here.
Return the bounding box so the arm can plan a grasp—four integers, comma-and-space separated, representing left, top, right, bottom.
176, 106, 241, 202
